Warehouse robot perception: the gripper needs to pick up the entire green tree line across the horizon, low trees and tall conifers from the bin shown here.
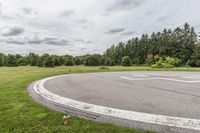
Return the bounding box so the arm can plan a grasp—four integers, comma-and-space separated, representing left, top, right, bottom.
0, 23, 200, 67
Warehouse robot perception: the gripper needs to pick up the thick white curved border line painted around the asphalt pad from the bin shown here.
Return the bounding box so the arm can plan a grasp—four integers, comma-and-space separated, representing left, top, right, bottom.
34, 76, 200, 130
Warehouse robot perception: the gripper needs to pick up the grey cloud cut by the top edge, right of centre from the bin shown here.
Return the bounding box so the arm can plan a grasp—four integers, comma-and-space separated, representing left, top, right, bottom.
106, 0, 145, 12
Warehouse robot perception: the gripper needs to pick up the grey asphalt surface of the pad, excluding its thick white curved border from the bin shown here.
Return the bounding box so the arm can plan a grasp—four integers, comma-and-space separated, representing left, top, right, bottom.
29, 72, 200, 132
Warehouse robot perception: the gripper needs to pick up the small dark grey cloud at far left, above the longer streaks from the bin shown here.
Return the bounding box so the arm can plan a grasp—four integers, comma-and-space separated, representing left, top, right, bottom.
1, 26, 25, 36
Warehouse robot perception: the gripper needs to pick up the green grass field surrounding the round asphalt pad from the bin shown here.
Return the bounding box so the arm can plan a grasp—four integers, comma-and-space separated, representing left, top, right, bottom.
0, 66, 200, 133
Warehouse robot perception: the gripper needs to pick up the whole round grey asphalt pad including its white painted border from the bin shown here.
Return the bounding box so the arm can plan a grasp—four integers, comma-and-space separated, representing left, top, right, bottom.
29, 72, 200, 133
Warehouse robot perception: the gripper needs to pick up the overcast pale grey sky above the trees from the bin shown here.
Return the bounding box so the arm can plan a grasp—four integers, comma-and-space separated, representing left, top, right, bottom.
0, 0, 200, 55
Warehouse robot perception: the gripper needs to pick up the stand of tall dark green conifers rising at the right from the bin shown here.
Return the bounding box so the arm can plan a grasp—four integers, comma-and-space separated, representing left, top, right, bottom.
104, 23, 200, 67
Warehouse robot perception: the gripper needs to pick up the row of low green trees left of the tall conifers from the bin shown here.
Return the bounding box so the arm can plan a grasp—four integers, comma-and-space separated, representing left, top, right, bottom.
0, 53, 104, 67
